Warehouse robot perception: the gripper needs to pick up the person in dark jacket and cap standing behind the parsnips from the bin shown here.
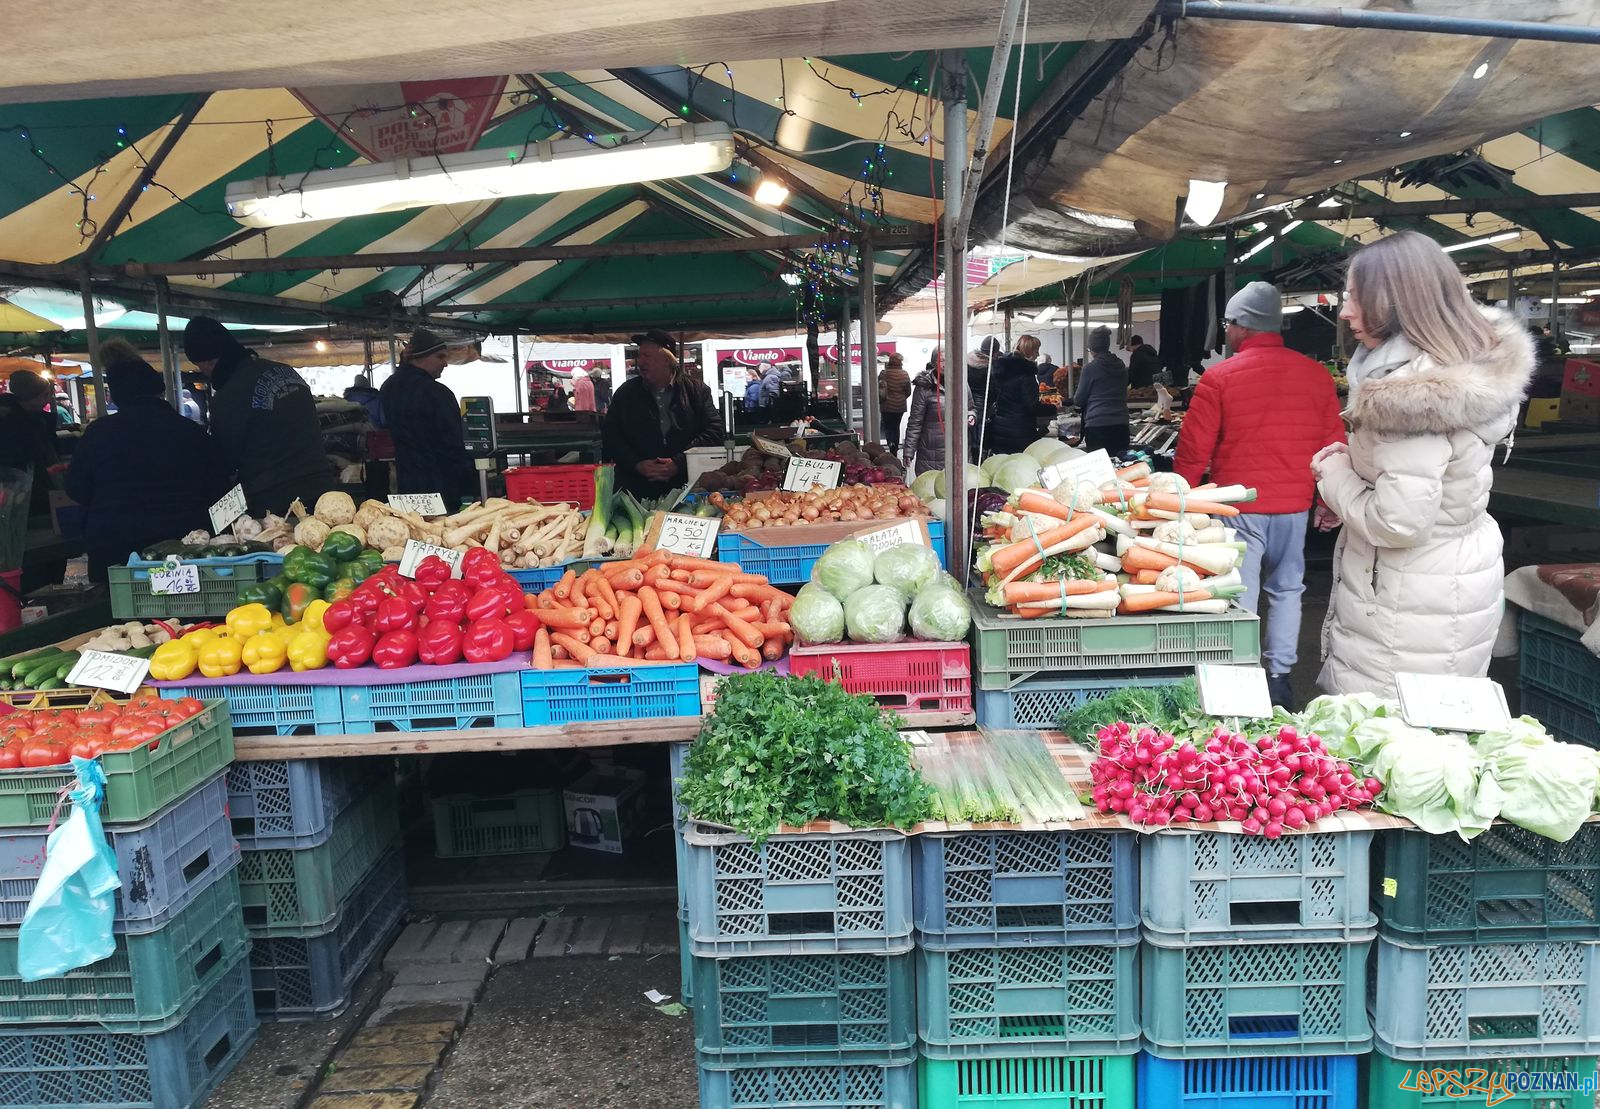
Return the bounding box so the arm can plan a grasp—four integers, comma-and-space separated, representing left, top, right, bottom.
378, 328, 470, 512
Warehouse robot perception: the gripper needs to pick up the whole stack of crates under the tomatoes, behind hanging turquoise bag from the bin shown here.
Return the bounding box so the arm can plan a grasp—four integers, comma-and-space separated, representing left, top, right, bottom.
0, 704, 256, 1109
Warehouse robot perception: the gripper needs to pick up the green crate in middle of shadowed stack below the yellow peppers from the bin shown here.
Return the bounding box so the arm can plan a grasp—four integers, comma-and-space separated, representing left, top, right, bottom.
238, 781, 400, 936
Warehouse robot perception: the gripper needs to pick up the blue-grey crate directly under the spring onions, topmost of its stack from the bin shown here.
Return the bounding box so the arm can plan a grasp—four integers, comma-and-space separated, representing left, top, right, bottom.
912, 832, 1139, 944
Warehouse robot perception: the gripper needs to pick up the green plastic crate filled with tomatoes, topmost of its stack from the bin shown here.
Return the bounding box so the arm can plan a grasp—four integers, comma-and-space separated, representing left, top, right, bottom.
0, 701, 234, 827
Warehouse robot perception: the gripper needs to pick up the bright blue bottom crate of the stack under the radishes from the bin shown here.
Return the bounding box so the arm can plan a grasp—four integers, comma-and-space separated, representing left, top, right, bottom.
1138, 1053, 1360, 1109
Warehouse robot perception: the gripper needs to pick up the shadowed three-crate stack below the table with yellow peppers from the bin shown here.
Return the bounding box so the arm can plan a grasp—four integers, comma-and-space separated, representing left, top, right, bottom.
227, 759, 406, 1021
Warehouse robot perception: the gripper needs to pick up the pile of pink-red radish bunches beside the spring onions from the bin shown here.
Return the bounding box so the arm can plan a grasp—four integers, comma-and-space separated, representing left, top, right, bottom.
1091, 722, 1382, 839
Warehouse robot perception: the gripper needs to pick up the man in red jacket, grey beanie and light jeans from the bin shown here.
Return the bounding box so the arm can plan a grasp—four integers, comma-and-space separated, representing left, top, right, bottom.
1174, 282, 1344, 709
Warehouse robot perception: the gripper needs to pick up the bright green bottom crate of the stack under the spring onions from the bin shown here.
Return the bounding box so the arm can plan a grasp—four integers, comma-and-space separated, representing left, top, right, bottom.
917, 1055, 1134, 1109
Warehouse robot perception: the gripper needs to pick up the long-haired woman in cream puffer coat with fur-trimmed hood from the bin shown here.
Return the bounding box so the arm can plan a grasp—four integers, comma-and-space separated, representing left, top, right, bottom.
1312, 232, 1534, 698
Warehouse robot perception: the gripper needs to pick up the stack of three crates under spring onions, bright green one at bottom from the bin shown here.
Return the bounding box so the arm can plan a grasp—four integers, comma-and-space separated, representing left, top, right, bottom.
912, 831, 1139, 1109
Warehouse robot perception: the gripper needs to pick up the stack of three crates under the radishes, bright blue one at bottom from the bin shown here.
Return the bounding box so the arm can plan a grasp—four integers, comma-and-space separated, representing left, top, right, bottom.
1139, 831, 1376, 1109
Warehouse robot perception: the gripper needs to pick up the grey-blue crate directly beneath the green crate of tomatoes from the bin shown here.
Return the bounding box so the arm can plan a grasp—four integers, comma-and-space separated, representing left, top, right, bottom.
0, 775, 238, 935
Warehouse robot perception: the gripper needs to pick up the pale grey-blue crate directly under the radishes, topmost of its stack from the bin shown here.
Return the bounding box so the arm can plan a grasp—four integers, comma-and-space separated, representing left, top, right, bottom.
1139, 831, 1378, 941
